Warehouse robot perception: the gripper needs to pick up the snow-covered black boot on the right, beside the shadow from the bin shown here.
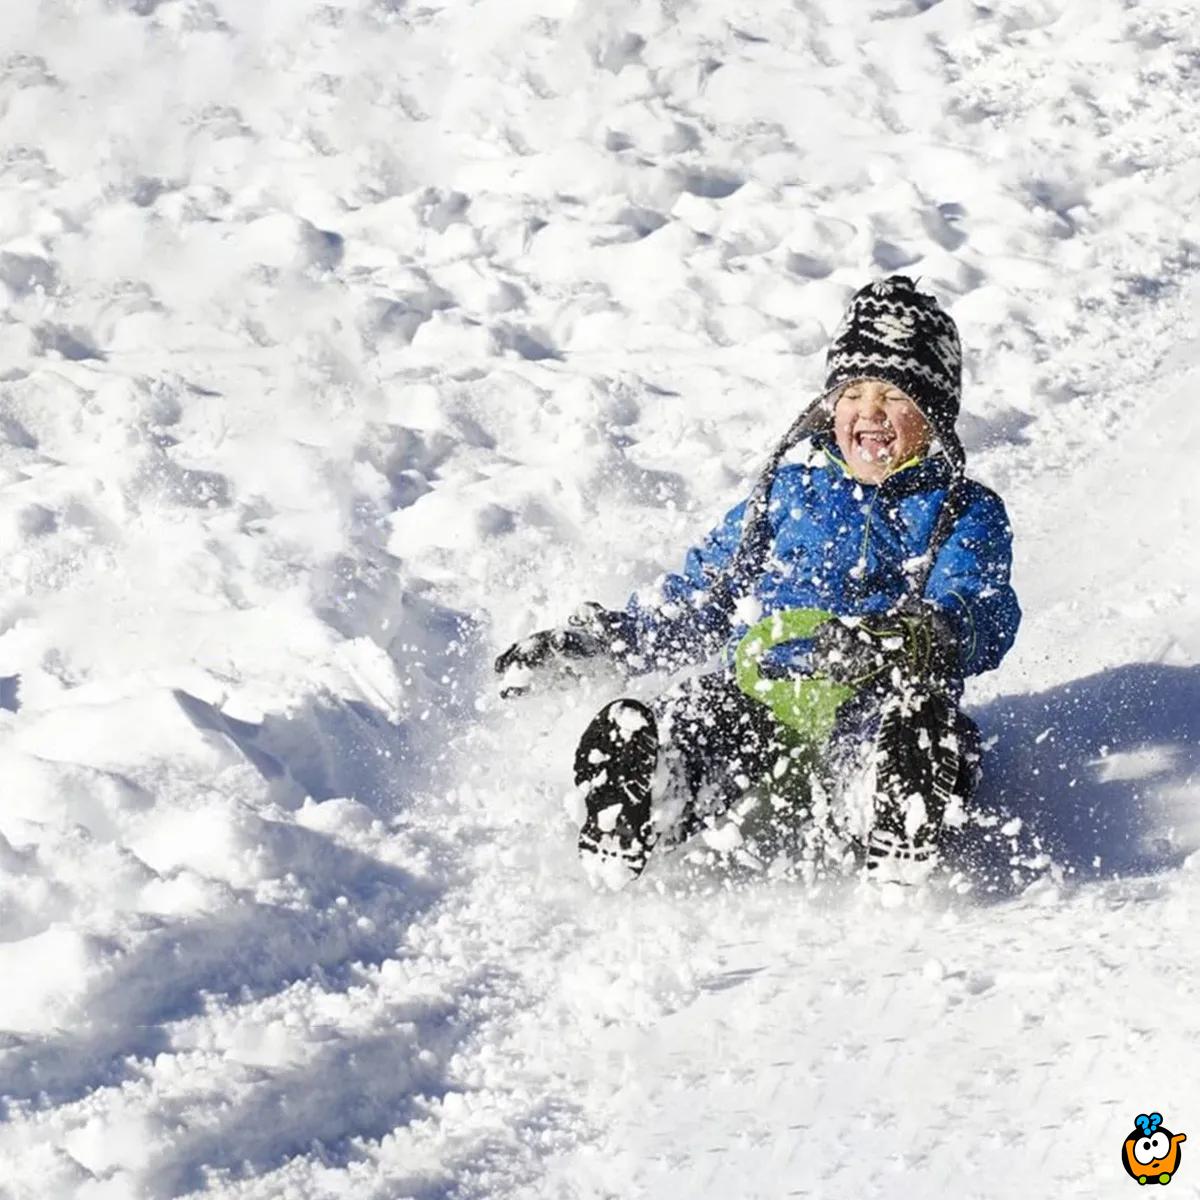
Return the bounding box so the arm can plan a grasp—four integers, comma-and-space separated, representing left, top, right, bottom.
866, 692, 979, 884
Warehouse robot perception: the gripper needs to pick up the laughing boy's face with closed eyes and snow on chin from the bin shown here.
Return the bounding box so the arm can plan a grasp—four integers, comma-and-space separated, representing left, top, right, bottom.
833, 379, 932, 484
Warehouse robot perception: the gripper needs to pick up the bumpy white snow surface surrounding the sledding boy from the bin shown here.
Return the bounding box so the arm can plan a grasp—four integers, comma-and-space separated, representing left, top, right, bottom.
0, 0, 1200, 1200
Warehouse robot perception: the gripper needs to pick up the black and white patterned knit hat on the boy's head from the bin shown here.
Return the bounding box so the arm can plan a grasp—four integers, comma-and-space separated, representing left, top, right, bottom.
826, 275, 966, 468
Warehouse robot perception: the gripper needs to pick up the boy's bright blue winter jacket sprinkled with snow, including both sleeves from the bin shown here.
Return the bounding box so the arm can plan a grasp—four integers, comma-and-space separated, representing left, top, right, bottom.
626, 436, 1021, 674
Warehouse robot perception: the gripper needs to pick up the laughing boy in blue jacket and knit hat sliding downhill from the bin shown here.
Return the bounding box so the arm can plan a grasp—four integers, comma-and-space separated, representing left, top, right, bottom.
496, 275, 1020, 887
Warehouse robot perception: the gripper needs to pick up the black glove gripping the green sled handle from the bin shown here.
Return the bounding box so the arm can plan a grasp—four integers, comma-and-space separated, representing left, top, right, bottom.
811, 604, 958, 686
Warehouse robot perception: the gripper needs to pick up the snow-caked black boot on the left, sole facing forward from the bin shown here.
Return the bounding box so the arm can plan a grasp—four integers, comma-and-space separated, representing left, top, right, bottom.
575, 700, 659, 890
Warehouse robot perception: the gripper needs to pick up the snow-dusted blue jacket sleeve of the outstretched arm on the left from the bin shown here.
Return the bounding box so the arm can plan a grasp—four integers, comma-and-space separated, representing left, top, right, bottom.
625, 502, 745, 671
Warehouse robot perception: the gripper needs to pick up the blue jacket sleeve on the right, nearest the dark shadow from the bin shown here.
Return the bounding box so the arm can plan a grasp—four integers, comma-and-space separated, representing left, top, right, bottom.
925, 487, 1021, 674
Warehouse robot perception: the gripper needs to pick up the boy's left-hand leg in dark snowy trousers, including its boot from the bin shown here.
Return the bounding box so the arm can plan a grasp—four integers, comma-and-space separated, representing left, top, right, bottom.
575, 672, 793, 887
